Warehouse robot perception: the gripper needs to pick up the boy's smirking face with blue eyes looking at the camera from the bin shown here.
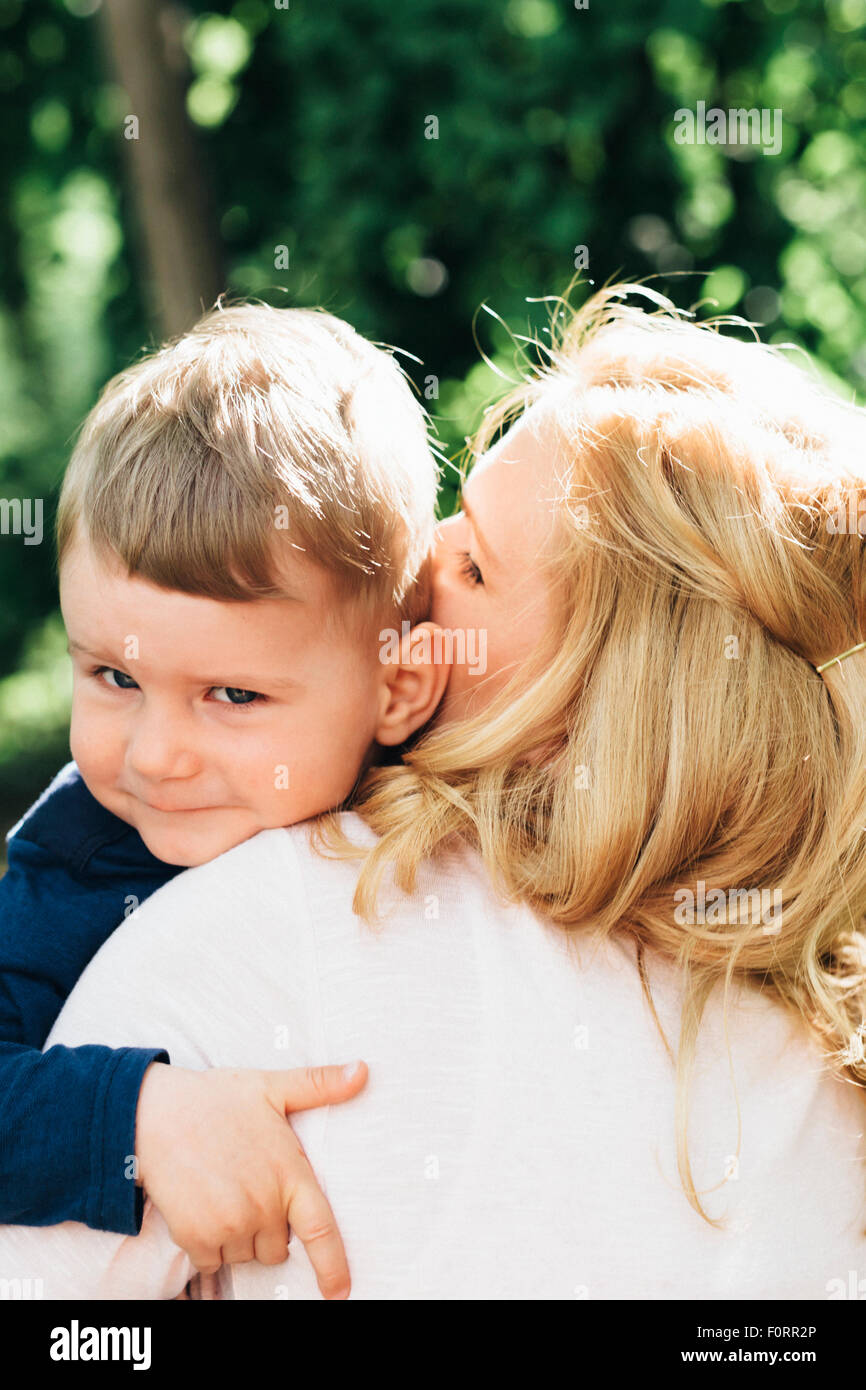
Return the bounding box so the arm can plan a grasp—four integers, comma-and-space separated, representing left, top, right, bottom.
60, 534, 384, 866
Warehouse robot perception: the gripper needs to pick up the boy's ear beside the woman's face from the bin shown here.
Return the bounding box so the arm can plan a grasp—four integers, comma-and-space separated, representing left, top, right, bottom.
374, 623, 450, 748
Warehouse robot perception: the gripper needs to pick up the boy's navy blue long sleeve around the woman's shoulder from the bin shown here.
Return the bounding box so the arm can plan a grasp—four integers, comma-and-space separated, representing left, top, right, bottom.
0, 763, 179, 1236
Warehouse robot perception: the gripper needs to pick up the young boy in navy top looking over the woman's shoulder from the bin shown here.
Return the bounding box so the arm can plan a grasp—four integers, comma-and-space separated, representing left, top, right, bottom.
0, 304, 446, 1297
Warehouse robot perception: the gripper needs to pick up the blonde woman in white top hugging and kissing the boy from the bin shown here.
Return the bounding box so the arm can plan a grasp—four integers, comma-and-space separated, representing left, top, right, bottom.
0, 291, 866, 1298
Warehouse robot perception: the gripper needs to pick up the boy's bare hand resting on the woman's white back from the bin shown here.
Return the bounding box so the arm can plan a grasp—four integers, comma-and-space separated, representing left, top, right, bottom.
135, 1062, 367, 1298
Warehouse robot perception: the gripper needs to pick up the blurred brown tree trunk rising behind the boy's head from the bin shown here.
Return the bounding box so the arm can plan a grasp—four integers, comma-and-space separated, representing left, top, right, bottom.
100, 0, 225, 336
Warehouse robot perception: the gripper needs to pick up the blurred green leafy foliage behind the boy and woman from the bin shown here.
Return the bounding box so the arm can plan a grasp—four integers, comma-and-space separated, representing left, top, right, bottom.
0, 0, 866, 821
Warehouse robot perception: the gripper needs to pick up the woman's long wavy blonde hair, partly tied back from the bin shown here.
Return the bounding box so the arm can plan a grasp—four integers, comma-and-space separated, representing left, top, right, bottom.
321, 286, 866, 1215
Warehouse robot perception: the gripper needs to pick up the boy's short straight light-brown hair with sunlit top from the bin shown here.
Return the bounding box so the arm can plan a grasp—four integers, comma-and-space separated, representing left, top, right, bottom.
57, 302, 438, 627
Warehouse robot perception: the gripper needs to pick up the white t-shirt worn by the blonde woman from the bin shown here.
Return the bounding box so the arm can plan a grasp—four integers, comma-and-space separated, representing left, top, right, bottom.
0, 815, 866, 1300
